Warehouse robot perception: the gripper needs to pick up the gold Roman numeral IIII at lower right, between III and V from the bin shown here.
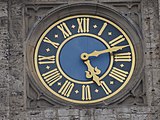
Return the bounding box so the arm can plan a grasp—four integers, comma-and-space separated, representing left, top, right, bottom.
109, 67, 128, 83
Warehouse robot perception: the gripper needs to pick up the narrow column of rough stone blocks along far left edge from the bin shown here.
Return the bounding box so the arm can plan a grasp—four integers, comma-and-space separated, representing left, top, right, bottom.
0, 2, 9, 119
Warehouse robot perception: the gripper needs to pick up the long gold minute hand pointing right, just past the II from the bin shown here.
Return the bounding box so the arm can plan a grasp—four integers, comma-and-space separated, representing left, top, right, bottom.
81, 45, 129, 60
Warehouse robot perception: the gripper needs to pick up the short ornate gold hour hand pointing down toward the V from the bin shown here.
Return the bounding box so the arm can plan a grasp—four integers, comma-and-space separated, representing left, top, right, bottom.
84, 60, 101, 86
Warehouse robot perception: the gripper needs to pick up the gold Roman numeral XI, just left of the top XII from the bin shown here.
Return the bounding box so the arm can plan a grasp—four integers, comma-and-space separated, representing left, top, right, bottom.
57, 22, 72, 38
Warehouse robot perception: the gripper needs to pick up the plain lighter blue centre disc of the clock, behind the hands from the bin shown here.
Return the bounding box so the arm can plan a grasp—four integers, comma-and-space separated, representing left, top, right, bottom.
59, 36, 110, 81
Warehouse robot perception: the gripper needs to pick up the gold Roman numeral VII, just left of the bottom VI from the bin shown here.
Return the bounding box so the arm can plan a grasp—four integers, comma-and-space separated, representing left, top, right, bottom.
58, 80, 74, 97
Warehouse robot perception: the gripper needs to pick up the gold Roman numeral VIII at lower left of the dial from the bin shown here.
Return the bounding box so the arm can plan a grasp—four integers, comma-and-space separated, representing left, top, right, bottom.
42, 68, 62, 86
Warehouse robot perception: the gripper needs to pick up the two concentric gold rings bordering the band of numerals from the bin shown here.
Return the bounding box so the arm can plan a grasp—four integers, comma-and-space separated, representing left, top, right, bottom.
34, 15, 135, 104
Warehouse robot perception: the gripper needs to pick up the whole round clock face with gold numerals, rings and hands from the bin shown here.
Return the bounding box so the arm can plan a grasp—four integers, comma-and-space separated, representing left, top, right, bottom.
34, 15, 135, 104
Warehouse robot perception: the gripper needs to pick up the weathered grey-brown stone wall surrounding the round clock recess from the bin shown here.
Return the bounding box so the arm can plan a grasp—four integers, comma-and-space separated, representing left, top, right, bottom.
0, 0, 160, 120
